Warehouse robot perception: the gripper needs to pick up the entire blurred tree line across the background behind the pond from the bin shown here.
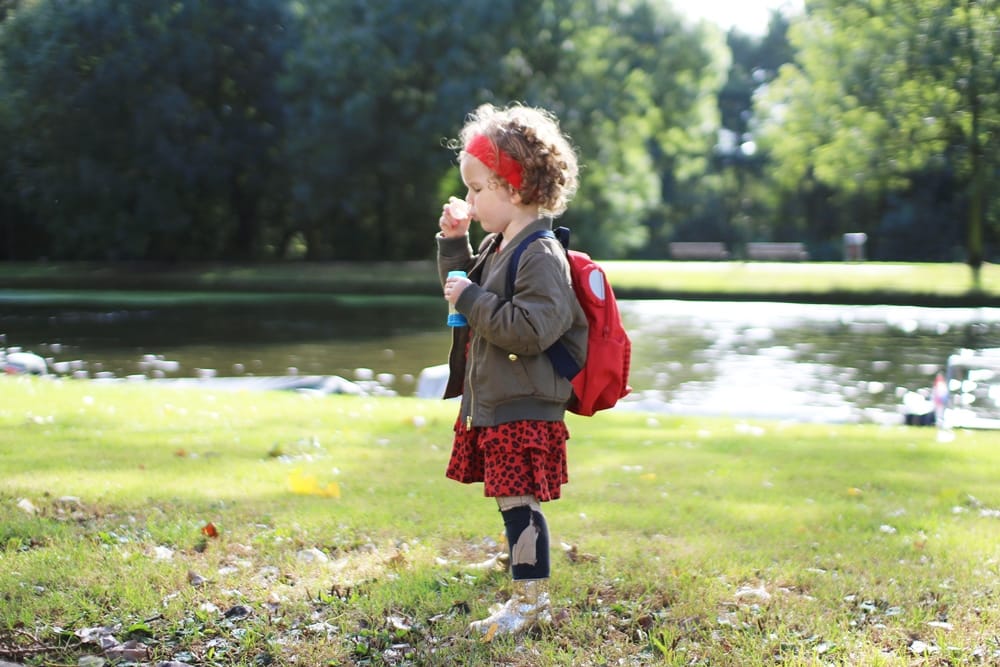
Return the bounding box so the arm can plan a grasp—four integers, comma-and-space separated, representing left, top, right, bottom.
0, 0, 1000, 267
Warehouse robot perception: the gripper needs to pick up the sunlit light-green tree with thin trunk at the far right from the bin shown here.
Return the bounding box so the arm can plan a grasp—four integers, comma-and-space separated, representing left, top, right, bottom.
759, 0, 1000, 276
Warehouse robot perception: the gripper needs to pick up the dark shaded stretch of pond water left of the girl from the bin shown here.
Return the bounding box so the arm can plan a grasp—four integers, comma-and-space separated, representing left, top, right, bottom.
0, 296, 448, 395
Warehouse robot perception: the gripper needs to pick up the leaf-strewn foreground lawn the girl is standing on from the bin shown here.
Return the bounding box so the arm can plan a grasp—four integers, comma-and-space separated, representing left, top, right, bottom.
0, 377, 1000, 666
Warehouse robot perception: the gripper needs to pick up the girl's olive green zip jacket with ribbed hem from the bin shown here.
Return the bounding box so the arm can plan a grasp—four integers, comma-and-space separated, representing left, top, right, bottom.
437, 219, 587, 426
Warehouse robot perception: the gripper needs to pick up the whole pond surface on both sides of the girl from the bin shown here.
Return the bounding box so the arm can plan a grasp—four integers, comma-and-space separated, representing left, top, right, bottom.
0, 297, 1000, 421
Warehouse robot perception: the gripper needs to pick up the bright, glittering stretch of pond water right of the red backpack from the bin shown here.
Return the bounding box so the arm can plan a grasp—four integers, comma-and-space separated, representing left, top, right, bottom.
626, 301, 1000, 421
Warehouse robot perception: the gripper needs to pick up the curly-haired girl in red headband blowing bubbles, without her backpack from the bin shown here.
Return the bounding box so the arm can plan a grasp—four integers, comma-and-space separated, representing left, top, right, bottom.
437, 105, 587, 636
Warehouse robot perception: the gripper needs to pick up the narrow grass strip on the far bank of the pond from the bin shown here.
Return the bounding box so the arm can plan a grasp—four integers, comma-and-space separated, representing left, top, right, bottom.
0, 261, 1000, 305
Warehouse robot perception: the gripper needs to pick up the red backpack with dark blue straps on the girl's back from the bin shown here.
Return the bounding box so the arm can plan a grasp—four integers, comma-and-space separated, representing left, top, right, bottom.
507, 227, 632, 416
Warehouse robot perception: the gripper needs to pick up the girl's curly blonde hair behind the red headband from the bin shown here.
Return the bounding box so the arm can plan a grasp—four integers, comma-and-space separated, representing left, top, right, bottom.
449, 104, 579, 217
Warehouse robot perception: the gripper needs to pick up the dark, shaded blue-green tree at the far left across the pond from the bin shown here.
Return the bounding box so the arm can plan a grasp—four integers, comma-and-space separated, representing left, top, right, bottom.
0, 0, 288, 259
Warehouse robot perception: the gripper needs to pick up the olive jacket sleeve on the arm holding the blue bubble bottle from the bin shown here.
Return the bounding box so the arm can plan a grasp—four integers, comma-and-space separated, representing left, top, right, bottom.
457, 242, 576, 355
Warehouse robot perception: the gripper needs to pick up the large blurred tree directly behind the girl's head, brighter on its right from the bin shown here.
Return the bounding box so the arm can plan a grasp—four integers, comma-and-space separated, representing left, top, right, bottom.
285, 0, 724, 259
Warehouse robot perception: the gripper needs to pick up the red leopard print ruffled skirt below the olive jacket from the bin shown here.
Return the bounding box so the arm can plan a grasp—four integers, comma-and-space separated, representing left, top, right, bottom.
445, 419, 569, 502
